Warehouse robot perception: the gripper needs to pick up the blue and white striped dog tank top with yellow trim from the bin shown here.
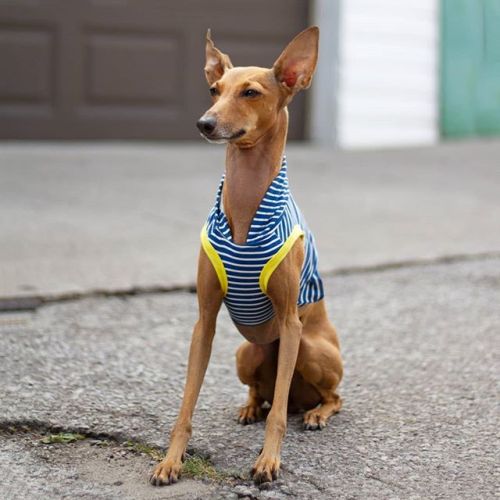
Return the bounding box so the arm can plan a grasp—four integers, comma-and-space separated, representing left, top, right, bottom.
201, 157, 324, 325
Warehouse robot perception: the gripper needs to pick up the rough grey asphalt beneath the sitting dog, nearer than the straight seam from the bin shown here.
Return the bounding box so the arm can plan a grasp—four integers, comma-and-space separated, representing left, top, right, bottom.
0, 258, 500, 500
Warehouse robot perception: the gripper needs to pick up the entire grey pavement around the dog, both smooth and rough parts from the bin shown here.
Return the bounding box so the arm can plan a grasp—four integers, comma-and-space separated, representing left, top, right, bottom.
0, 139, 500, 500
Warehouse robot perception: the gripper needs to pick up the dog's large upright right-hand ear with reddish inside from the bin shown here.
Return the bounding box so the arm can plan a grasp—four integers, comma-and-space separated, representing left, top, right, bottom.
273, 26, 319, 95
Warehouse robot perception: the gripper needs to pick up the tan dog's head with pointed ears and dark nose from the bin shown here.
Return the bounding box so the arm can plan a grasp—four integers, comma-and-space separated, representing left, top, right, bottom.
197, 26, 319, 147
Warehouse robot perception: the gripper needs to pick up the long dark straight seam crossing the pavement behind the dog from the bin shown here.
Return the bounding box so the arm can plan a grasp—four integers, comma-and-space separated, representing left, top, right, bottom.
0, 251, 500, 314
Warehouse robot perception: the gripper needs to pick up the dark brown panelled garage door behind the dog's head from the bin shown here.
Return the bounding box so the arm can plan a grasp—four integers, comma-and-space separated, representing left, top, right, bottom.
0, 0, 308, 139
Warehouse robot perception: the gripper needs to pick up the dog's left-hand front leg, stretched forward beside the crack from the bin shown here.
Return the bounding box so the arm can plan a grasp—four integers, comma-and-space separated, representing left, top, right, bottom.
150, 250, 222, 486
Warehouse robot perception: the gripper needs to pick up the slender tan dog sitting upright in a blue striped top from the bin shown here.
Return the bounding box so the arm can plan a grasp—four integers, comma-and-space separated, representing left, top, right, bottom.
151, 27, 342, 485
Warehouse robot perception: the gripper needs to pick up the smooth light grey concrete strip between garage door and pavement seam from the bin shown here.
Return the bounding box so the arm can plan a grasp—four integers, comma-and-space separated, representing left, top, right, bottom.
0, 140, 500, 298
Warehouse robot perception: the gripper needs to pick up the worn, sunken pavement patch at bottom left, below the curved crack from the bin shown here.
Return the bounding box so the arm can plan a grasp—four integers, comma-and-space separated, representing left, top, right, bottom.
0, 432, 216, 500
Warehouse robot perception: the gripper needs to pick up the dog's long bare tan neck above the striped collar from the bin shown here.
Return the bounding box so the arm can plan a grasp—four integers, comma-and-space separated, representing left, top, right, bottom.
223, 108, 288, 245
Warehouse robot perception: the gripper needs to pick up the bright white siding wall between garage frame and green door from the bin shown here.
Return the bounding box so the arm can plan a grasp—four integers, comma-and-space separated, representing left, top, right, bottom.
337, 0, 439, 148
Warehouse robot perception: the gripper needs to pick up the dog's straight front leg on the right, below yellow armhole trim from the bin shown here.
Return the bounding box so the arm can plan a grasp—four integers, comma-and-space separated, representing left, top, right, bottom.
252, 240, 304, 483
